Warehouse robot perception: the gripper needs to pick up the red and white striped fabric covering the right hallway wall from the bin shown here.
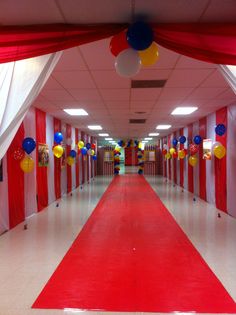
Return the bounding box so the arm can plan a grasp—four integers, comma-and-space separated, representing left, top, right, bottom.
161, 105, 236, 217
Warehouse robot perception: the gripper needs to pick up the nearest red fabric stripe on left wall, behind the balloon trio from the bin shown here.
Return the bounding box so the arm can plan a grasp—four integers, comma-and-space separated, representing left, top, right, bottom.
7, 124, 24, 229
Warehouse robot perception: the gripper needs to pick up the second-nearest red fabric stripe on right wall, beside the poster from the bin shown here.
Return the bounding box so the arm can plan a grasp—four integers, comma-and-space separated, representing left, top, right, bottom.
199, 117, 207, 201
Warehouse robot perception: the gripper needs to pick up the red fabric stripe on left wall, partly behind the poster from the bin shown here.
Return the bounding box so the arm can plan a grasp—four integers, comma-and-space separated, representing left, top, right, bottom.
35, 108, 48, 211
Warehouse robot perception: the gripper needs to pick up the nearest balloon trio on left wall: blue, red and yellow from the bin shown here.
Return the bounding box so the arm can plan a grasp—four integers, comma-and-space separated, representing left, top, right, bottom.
18, 137, 36, 173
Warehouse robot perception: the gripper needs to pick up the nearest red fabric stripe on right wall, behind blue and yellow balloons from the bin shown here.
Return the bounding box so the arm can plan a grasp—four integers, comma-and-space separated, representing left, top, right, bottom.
215, 107, 227, 212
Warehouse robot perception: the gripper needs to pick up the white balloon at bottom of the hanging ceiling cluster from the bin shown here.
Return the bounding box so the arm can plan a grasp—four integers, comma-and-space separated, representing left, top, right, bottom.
115, 48, 141, 77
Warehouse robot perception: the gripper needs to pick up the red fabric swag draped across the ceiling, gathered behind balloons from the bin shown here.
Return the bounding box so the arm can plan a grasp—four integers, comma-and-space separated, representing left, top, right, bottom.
0, 23, 236, 65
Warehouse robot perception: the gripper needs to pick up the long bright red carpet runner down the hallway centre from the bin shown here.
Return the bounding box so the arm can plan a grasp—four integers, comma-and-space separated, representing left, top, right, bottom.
33, 175, 236, 313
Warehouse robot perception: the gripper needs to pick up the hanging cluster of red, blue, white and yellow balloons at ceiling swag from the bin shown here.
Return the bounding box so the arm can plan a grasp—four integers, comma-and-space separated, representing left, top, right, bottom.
110, 21, 158, 77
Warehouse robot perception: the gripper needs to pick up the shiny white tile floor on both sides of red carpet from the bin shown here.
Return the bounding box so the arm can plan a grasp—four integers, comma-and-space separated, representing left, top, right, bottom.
0, 176, 236, 315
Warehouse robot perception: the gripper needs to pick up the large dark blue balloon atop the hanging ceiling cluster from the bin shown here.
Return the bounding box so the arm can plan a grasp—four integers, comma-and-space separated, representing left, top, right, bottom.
127, 21, 154, 50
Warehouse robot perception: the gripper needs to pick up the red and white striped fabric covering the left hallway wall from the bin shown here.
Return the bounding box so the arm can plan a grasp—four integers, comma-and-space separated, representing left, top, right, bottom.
0, 107, 94, 234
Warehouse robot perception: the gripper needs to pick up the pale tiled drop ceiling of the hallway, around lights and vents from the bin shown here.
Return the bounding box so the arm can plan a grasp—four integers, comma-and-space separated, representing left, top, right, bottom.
0, 0, 236, 144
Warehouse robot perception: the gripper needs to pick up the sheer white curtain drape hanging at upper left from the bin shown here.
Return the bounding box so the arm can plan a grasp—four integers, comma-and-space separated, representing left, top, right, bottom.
0, 52, 62, 159
